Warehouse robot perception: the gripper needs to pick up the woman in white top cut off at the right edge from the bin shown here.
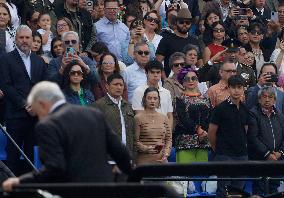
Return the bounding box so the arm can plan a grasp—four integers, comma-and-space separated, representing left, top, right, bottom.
270, 30, 284, 74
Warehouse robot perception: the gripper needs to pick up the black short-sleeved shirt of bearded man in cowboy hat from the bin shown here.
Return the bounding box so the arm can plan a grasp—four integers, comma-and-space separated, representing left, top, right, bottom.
156, 34, 202, 76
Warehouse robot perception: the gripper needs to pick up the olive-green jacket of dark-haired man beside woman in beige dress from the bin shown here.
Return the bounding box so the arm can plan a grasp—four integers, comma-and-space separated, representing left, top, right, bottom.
93, 95, 135, 160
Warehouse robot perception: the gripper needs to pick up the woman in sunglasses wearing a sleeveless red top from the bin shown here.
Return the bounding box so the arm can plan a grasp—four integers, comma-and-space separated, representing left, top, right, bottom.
203, 21, 226, 63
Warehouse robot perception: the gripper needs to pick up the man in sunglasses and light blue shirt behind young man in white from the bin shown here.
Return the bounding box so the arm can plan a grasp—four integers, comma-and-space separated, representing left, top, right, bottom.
122, 42, 150, 103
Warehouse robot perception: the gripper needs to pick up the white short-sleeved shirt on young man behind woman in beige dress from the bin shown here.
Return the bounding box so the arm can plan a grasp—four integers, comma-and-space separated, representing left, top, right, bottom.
132, 85, 173, 115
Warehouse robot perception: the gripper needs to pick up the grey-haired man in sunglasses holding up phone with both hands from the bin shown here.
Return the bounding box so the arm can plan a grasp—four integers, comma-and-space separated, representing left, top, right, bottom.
48, 31, 98, 87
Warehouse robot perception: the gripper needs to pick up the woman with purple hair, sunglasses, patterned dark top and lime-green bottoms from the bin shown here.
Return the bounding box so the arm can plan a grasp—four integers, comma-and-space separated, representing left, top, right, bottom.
174, 68, 210, 163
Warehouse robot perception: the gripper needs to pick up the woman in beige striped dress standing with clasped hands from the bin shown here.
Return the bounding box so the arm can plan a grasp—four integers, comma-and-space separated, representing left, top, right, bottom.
135, 87, 172, 165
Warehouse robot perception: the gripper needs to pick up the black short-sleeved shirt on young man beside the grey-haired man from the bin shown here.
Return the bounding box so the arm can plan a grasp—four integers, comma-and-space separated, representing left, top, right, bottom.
211, 99, 249, 157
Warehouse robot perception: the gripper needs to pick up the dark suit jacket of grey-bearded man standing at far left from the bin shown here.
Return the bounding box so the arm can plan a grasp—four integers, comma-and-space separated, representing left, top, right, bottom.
0, 49, 47, 119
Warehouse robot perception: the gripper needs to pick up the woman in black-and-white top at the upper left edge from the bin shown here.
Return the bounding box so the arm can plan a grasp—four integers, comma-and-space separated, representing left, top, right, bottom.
0, 3, 15, 53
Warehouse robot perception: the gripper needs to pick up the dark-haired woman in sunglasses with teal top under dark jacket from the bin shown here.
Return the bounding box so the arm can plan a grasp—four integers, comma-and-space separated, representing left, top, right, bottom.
63, 62, 95, 106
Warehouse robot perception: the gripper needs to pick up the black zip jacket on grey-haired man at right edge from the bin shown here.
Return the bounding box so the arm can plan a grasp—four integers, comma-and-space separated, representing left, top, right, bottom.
248, 105, 284, 160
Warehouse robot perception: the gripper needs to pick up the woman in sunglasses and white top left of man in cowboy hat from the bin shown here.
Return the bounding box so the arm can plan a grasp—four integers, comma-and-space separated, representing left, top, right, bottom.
143, 10, 163, 51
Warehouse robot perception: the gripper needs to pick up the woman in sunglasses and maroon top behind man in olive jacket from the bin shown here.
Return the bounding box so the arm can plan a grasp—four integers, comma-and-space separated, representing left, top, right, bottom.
94, 52, 127, 101
